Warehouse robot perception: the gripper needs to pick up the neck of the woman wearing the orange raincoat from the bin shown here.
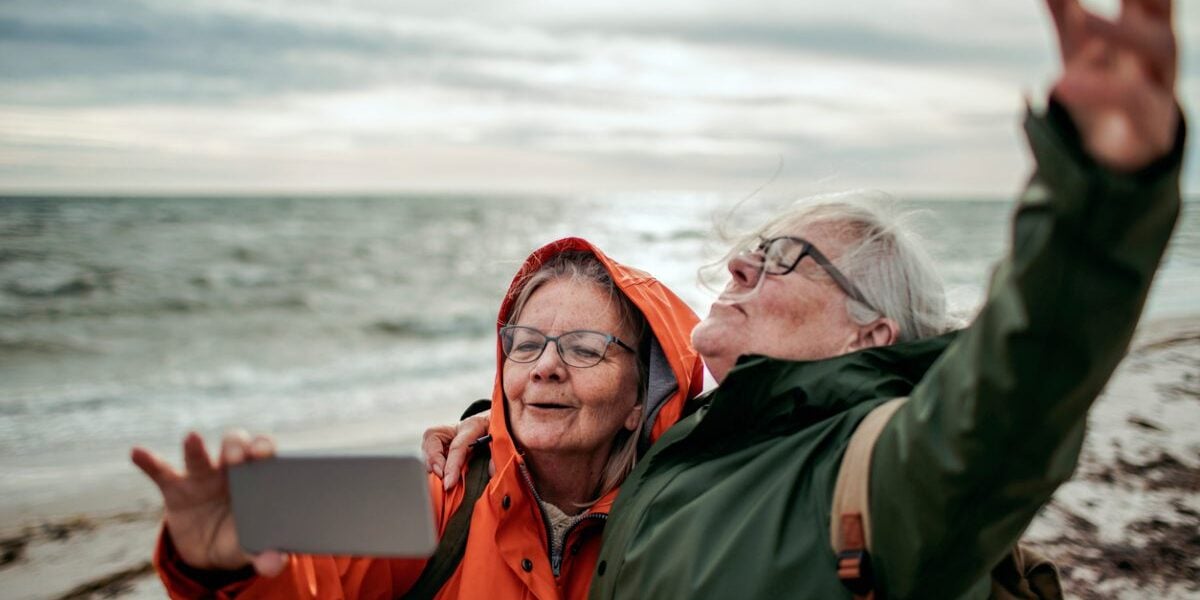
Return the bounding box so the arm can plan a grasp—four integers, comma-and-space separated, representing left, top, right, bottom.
526, 448, 610, 515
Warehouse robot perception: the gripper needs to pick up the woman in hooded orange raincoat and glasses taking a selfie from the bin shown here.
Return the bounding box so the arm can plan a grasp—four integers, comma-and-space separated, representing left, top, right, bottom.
132, 238, 702, 600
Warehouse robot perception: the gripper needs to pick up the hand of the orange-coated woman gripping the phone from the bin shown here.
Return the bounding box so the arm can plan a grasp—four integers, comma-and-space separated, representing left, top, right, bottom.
130, 431, 287, 576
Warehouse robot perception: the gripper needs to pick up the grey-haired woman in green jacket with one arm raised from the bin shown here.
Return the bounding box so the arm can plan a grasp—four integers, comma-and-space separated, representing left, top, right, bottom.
427, 0, 1183, 599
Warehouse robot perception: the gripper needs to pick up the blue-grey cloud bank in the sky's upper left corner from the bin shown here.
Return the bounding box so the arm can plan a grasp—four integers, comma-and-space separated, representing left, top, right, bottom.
0, 0, 571, 104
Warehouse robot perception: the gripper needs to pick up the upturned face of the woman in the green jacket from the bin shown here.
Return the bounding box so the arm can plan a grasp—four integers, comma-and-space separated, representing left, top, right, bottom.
691, 229, 859, 382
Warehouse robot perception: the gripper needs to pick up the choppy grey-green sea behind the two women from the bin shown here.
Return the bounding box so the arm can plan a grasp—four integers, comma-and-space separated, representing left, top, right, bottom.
0, 192, 1200, 528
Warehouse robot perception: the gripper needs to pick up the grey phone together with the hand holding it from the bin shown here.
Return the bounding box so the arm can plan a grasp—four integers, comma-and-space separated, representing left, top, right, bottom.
131, 431, 437, 576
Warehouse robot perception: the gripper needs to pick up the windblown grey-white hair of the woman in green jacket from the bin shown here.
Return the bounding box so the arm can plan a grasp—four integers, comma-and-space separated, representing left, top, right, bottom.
725, 191, 961, 342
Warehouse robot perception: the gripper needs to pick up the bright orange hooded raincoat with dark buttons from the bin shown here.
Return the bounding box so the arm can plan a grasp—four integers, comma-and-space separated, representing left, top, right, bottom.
155, 238, 703, 600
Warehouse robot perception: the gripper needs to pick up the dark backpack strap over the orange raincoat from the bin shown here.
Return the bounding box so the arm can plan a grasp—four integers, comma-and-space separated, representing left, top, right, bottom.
403, 436, 492, 600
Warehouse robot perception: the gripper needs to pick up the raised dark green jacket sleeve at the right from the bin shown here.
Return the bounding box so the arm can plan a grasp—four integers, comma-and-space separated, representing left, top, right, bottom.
869, 103, 1184, 598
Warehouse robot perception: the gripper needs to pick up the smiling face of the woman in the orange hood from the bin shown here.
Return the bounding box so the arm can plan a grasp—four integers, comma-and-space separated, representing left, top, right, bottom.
503, 278, 641, 457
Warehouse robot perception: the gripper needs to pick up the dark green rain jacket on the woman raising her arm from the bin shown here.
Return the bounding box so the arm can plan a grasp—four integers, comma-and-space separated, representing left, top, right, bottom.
590, 103, 1183, 600
